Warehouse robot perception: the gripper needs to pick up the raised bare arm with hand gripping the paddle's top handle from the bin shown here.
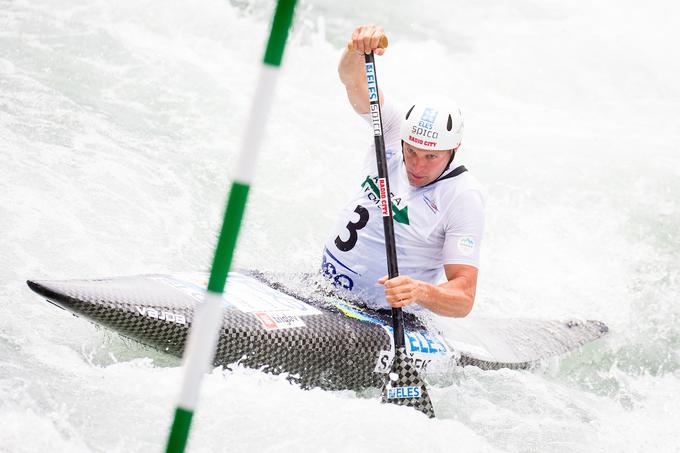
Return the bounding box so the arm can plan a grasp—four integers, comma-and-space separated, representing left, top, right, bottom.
338, 25, 385, 114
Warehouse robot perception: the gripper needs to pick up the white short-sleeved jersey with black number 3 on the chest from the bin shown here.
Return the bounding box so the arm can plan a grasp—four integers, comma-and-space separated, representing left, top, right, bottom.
322, 96, 485, 309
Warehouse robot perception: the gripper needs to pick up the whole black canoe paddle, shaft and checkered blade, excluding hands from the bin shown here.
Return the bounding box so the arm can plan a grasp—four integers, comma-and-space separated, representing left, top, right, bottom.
365, 47, 434, 417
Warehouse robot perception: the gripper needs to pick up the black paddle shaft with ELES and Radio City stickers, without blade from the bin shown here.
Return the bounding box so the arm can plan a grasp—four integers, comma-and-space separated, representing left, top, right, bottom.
364, 52, 405, 348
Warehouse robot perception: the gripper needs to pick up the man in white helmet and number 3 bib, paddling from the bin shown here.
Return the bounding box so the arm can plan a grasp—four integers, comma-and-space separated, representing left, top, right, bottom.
322, 25, 485, 317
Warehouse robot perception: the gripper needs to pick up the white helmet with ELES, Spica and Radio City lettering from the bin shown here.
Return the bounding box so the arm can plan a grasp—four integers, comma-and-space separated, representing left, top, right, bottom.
401, 100, 464, 151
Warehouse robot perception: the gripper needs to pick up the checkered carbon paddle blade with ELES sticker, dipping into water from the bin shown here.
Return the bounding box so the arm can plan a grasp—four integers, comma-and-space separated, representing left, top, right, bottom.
382, 348, 434, 418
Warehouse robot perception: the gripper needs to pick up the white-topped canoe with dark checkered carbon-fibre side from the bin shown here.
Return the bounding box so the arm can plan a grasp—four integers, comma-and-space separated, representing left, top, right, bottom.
27, 272, 606, 389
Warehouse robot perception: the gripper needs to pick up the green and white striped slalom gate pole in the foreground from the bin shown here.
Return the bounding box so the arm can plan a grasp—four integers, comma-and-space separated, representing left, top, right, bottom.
166, 0, 296, 453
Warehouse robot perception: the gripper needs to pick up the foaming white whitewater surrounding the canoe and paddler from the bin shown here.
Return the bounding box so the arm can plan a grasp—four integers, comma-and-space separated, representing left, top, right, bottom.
0, 0, 680, 452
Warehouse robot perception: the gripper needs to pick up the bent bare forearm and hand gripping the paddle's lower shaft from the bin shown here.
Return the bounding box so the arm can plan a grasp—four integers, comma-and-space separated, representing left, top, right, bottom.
378, 264, 478, 318
